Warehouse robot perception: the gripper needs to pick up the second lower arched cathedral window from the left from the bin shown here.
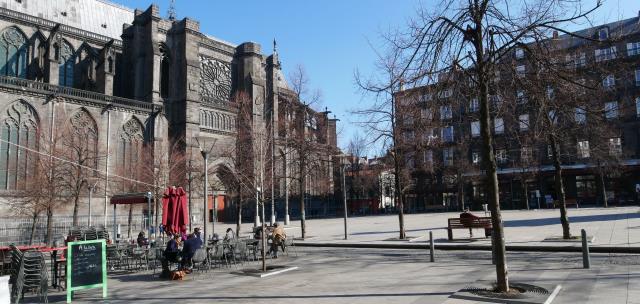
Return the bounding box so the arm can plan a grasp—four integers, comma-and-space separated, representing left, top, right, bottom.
63, 109, 98, 176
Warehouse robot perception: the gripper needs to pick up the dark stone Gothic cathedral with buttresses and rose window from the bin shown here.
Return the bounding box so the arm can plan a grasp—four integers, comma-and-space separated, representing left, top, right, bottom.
0, 0, 337, 226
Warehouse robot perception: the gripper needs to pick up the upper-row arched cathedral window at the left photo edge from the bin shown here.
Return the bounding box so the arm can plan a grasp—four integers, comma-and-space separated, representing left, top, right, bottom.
0, 27, 28, 78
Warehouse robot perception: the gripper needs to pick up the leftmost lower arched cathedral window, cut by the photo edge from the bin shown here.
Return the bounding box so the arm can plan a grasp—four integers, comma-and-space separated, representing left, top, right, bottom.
0, 100, 38, 190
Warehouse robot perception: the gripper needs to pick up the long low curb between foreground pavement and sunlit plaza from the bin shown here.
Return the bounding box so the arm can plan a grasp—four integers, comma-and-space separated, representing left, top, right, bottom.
295, 242, 640, 254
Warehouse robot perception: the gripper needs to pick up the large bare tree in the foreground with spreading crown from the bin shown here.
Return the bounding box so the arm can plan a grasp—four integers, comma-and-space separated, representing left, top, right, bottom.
360, 0, 601, 292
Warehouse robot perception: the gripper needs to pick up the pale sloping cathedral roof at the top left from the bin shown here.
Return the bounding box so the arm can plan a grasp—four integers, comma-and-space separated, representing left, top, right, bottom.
0, 0, 134, 40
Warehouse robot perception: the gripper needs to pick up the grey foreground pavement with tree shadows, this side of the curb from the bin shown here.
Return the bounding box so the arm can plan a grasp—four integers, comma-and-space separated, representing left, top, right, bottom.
33, 248, 640, 304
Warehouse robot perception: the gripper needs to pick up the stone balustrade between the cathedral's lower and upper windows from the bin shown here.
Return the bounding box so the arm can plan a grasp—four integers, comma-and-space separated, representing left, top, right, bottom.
0, 76, 160, 112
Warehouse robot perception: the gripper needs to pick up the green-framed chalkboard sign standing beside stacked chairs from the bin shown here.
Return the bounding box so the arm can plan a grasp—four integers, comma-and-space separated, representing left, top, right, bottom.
67, 240, 107, 303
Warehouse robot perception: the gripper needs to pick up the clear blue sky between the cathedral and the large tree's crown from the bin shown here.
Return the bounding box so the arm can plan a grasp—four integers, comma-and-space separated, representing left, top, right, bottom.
112, 0, 640, 154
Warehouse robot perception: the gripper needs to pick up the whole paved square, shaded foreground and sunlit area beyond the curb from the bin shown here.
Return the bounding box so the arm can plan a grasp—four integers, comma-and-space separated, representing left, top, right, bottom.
27, 207, 640, 304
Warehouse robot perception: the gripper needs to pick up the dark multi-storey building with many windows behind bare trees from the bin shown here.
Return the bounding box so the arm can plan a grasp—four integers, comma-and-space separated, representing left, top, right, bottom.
395, 16, 640, 211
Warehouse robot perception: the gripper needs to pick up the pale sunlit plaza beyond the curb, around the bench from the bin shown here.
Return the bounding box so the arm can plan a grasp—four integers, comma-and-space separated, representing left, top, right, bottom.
216, 207, 640, 247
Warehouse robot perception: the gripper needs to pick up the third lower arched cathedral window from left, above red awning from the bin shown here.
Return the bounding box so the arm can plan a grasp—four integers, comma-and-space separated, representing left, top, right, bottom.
117, 118, 144, 191
